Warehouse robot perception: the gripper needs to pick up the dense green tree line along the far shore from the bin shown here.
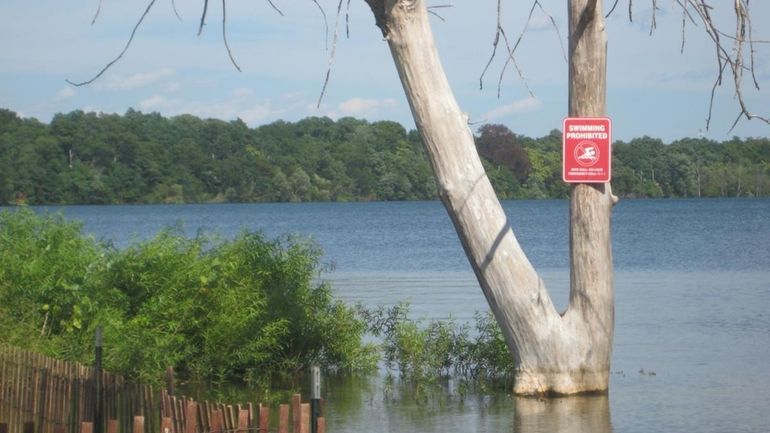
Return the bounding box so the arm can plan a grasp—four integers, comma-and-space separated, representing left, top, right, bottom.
0, 109, 770, 205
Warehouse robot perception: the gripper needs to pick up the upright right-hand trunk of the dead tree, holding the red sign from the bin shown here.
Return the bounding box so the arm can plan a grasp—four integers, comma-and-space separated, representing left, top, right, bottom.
565, 0, 617, 390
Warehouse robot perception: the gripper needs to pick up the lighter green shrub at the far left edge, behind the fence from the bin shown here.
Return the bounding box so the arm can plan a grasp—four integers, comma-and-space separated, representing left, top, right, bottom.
0, 208, 103, 338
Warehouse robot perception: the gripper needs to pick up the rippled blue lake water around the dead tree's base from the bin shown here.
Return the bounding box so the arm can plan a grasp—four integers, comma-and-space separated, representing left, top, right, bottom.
24, 199, 770, 433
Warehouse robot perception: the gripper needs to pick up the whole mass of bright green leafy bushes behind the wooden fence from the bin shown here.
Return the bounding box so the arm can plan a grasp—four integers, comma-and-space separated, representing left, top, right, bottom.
0, 209, 376, 384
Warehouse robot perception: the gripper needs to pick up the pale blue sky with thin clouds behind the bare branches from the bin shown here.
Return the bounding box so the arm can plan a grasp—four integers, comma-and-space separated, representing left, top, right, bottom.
0, 0, 770, 141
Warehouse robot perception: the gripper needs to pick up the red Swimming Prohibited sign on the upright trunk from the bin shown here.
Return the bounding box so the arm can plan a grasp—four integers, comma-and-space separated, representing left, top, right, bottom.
562, 117, 612, 183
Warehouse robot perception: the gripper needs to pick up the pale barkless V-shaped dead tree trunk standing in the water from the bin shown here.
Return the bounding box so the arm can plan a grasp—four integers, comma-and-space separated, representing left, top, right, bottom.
367, 0, 613, 394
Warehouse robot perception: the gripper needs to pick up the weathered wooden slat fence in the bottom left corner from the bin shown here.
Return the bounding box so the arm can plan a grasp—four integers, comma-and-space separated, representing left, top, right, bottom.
0, 345, 326, 433
